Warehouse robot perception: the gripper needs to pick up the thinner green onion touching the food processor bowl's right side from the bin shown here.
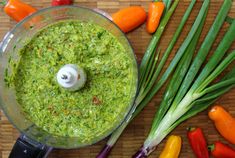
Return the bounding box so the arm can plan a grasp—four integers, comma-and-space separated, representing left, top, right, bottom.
97, 0, 197, 158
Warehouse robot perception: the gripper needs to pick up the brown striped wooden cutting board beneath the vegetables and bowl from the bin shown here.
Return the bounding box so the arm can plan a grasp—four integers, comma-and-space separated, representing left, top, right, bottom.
0, 0, 235, 158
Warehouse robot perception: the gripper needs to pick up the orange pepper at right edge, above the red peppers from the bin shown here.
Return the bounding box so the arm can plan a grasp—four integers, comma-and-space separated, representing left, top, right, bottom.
208, 105, 235, 144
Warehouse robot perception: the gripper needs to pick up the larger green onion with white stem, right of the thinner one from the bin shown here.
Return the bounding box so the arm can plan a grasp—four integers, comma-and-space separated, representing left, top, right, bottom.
133, 0, 235, 158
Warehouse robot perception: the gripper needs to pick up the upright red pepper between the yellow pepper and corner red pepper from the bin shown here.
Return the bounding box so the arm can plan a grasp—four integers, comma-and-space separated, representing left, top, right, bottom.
187, 127, 209, 158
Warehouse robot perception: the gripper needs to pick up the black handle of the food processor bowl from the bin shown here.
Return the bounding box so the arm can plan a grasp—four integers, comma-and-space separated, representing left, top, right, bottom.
9, 135, 52, 158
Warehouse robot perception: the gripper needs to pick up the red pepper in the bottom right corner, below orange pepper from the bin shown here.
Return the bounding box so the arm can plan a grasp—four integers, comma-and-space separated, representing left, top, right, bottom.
208, 141, 235, 158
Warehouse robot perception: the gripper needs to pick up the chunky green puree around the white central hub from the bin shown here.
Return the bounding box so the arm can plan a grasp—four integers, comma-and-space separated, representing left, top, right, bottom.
5, 21, 132, 141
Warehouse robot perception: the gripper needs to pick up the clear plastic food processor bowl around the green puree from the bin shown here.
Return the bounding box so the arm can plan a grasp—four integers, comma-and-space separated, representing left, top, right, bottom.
0, 6, 138, 156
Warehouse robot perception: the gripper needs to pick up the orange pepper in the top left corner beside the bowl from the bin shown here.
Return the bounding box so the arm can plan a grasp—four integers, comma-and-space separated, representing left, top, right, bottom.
3, 0, 37, 22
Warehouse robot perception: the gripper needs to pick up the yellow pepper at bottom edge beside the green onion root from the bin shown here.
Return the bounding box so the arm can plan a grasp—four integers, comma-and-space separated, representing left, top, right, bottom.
159, 135, 182, 158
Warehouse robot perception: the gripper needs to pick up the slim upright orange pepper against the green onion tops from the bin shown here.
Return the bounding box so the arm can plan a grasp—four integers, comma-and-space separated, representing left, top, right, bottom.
146, 2, 165, 33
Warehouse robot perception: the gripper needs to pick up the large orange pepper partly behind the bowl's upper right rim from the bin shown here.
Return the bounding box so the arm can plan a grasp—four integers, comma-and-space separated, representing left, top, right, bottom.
112, 6, 147, 33
